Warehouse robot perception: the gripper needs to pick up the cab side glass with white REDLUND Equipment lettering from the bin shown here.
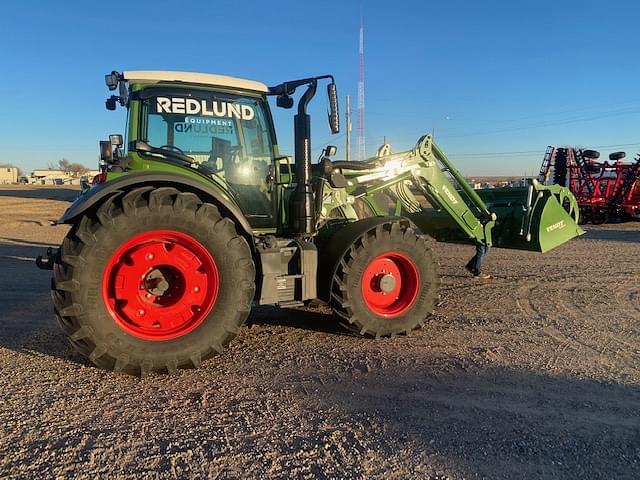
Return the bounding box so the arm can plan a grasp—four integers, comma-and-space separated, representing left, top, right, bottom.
140, 91, 275, 227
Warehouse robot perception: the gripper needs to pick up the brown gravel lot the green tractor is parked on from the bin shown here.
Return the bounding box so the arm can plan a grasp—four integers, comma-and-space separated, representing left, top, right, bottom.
0, 187, 640, 480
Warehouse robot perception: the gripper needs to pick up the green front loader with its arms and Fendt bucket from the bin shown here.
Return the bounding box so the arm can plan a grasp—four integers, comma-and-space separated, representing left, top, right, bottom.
323, 135, 584, 252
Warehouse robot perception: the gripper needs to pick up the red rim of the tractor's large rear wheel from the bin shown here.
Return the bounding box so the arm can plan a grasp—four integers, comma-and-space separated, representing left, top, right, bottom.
102, 230, 219, 340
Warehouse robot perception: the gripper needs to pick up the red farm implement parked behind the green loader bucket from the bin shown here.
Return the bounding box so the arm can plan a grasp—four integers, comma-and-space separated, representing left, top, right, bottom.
539, 146, 640, 223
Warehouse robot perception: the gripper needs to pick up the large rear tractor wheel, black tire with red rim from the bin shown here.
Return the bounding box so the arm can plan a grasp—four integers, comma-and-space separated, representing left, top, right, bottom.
51, 187, 255, 376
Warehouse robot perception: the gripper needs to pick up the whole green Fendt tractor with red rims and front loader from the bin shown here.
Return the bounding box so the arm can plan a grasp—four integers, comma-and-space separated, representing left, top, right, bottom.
37, 71, 583, 375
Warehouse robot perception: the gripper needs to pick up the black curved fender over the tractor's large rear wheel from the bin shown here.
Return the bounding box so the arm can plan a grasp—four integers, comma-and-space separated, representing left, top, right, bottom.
56, 172, 253, 236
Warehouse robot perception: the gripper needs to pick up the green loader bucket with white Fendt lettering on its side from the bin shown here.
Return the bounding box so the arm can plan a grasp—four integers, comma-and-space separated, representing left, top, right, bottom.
478, 180, 585, 253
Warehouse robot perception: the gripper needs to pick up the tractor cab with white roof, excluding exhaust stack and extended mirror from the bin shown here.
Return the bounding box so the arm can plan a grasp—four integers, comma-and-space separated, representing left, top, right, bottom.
103, 71, 277, 229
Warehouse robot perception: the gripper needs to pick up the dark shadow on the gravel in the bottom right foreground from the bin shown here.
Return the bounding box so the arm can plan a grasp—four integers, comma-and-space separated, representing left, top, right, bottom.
296, 364, 640, 479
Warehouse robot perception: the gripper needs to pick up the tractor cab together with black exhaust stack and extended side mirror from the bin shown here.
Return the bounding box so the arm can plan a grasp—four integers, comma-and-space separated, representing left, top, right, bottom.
101, 71, 339, 235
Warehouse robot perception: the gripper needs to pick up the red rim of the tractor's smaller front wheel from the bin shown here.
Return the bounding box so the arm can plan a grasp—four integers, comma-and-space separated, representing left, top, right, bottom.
362, 252, 420, 317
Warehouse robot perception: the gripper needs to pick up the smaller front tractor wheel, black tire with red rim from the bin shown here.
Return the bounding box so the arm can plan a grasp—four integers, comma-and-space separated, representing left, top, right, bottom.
330, 222, 439, 338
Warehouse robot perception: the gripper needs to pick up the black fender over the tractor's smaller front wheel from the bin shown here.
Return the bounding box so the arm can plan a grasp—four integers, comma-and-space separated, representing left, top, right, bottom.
318, 217, 410, 302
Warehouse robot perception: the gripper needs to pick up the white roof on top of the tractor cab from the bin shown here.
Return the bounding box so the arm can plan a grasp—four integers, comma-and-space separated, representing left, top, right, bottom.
123, 70, 269, 93
